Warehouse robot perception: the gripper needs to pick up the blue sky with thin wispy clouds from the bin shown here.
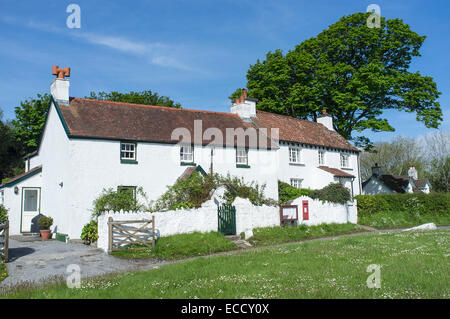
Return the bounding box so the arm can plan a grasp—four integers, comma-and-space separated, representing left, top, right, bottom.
0, 0, 450, 140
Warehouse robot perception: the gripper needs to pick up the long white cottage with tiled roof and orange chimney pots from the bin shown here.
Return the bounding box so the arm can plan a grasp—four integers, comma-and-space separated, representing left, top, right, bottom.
0, 67, 361, 238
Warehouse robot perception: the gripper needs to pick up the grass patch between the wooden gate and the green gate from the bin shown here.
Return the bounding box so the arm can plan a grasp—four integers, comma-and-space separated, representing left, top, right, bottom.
112, 232, 237, 260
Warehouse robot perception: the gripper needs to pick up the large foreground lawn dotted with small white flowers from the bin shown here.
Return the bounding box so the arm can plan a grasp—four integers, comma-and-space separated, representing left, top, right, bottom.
2, 230, 450, 298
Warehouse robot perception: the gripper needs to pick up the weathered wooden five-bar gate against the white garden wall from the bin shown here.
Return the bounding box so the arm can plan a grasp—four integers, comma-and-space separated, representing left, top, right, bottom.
108, 216, 156, 252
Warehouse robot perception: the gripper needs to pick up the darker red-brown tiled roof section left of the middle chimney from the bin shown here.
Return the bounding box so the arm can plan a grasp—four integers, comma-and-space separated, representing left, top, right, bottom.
59, 98, 275, 148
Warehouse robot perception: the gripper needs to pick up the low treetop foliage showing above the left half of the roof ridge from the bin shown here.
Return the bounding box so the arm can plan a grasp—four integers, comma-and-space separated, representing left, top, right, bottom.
87, 90, 181, 108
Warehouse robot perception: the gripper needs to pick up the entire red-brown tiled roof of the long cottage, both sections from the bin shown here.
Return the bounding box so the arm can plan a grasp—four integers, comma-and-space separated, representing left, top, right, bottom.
59, 98, 358, 151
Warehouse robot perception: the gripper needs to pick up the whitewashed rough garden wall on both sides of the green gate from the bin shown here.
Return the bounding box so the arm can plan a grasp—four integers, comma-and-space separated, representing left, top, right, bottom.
97, 198, 280, 251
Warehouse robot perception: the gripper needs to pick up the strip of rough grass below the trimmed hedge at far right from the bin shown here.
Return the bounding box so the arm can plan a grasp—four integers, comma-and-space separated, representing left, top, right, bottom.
358, 212, 450, 229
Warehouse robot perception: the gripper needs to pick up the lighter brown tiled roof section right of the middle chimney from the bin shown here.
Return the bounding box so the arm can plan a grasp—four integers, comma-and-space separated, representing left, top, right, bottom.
252, 111, 359, 152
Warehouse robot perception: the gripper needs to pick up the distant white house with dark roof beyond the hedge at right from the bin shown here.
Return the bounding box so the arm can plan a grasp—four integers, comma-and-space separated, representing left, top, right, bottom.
362, 164, 431, 194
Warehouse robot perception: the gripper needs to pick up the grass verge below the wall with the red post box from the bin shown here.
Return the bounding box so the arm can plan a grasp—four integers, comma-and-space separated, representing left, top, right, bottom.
249, 223, 366, 246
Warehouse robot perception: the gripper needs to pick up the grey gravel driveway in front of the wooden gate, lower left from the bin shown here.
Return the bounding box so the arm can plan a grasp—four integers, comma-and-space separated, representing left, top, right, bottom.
0, 238, 168, 288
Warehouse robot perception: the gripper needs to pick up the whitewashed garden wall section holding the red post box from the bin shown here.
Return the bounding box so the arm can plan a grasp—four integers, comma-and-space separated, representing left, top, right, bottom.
290, 196, 358, 225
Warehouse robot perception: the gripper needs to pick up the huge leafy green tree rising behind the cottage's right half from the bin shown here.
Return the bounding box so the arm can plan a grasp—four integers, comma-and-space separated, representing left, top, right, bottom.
230, 13, 442, 146
